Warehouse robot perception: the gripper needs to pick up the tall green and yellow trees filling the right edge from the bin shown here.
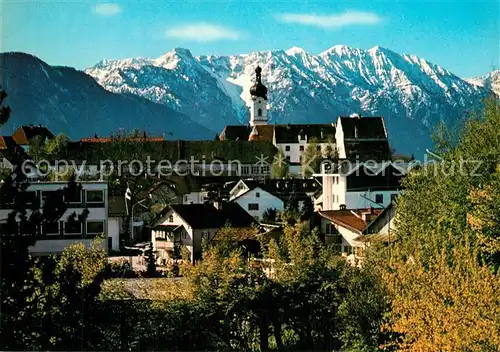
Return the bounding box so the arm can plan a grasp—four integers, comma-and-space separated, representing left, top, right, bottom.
377, 98, 500, 351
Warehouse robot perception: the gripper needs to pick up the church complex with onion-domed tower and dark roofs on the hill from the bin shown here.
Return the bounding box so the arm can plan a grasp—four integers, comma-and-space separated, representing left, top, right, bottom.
219, 66, 391, 174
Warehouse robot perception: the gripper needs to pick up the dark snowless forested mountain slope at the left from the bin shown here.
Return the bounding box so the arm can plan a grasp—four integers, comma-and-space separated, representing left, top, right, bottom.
0, 53, 215, 139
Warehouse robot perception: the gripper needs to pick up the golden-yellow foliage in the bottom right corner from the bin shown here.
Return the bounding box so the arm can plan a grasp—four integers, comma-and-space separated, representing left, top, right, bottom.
383, 245, 500, 352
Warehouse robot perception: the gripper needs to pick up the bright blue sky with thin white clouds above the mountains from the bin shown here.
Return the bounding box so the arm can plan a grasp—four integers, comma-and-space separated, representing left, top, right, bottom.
0, 0, 500, 77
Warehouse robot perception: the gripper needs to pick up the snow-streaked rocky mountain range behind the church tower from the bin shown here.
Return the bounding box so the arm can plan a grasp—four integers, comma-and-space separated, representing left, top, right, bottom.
86, 45, 487, 153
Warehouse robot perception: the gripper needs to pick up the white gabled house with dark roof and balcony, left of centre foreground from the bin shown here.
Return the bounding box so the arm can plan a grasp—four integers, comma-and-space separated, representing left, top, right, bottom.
151, 203, 256, 263
